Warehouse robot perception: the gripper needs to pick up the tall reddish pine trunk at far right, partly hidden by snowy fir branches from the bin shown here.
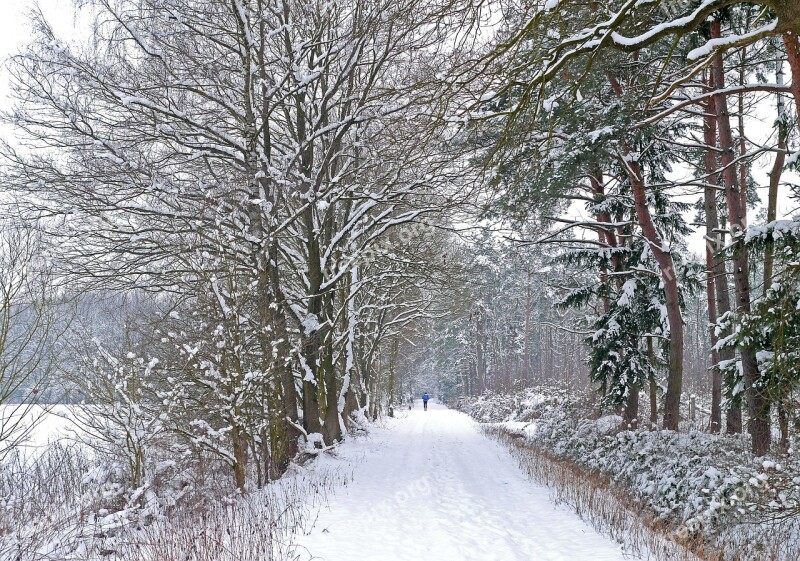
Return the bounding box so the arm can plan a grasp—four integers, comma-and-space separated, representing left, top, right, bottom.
711, 20, 770, 456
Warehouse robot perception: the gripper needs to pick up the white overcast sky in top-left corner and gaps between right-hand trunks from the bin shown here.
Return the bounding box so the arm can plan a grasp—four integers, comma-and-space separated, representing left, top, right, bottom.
0, 0, 800, 256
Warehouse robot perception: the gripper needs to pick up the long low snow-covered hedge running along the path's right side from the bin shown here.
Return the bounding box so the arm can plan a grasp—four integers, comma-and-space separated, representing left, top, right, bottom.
460, 389, 800, 538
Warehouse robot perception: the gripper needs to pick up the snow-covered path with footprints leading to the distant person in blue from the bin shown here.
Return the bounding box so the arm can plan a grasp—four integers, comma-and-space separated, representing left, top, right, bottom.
299, 404, 630, 561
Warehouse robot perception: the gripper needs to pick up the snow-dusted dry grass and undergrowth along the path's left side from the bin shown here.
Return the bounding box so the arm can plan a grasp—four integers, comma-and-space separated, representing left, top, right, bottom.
0, 443, 351, 561
